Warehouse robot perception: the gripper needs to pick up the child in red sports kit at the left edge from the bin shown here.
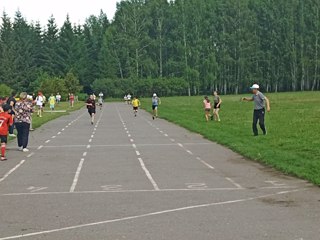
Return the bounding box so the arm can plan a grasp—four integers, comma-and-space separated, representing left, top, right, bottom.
0, 104, 13, 161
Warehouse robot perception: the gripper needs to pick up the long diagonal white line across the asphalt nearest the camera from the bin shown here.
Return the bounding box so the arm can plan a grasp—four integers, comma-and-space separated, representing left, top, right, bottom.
0, 189, 306, 240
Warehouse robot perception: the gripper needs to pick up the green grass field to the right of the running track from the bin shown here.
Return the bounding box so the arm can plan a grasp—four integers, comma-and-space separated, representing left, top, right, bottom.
142, 92, 320, 185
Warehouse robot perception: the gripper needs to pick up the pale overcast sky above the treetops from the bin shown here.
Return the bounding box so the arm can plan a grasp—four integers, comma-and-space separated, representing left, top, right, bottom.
0, 0, 119, 26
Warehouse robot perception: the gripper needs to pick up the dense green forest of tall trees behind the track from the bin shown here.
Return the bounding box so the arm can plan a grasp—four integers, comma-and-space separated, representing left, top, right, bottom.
0, 0, 320, 97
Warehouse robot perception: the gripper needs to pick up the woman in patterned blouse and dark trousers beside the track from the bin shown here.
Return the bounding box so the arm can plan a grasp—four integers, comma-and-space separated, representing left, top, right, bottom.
16, 92, 32, 152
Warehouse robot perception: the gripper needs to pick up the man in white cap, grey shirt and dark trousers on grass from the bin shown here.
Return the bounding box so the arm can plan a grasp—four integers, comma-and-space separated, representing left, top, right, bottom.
242, 84, 270, 136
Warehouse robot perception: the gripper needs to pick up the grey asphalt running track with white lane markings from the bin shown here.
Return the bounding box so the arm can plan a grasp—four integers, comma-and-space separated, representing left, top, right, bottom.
0, 103, 320, 240
